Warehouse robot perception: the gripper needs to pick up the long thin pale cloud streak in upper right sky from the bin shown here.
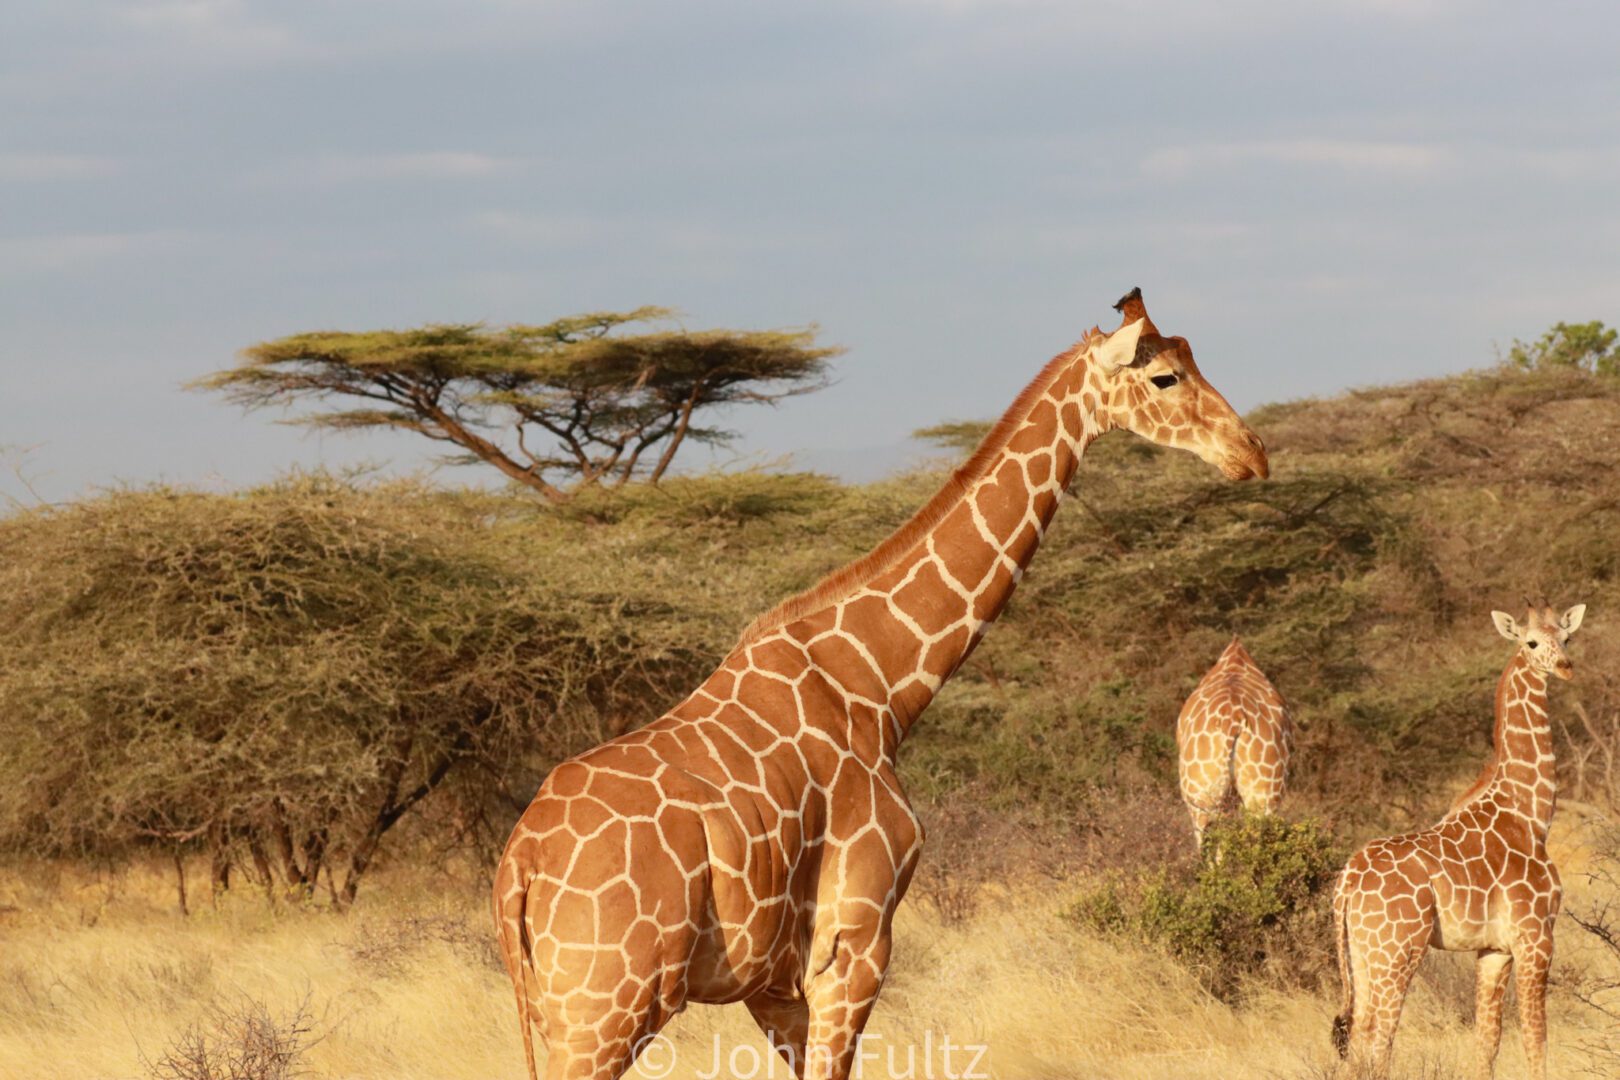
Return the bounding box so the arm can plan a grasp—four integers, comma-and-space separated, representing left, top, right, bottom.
1140, 139, 1453, 180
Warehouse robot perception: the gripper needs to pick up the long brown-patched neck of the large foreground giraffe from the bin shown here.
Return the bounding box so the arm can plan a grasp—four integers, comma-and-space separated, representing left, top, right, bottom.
740, 343, 1108, 753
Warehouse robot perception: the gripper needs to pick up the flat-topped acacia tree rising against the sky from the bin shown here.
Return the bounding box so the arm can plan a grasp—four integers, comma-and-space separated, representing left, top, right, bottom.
191, 308, 842, 502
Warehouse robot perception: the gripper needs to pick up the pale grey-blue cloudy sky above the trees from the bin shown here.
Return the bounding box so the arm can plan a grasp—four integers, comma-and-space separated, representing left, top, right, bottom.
0, 0, 1620, 499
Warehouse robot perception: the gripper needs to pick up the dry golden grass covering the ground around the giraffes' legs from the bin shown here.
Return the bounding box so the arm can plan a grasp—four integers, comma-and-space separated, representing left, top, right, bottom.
0, 818, 1602, 1080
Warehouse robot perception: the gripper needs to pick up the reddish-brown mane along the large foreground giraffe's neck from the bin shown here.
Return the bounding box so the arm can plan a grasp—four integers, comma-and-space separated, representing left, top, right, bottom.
737, 327, 1100, 646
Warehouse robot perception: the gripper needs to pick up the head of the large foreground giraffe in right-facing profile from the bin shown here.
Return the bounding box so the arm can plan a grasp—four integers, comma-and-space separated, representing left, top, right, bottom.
1090, 288, 1270, 479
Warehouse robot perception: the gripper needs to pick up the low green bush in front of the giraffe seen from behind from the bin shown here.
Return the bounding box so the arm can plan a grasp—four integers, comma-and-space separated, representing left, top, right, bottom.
1069, 814, 1343, 997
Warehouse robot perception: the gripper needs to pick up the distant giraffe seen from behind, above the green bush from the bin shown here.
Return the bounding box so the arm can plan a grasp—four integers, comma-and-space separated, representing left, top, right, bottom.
1176, 635, 1294, 847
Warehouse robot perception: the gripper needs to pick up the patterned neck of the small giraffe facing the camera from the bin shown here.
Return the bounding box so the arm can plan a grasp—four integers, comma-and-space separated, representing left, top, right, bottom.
1481, 651, 1558, 837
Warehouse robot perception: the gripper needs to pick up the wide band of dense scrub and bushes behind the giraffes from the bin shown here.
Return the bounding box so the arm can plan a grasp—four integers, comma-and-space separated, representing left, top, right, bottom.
0, 368, 1620, 905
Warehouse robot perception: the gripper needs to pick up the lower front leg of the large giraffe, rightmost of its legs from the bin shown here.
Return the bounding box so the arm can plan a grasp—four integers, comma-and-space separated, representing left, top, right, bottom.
800, 904, 891, 1080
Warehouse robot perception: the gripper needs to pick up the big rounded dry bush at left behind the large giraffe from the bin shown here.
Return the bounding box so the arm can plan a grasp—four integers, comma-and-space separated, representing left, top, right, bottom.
0, 476, 745, 905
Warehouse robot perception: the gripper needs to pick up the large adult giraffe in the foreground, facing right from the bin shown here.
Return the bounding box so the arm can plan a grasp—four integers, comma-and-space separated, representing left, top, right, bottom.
494, 290, 1267, 1080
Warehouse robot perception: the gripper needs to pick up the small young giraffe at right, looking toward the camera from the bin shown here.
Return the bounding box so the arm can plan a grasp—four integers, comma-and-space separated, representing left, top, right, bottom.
1333, 604, 1586, 1080
